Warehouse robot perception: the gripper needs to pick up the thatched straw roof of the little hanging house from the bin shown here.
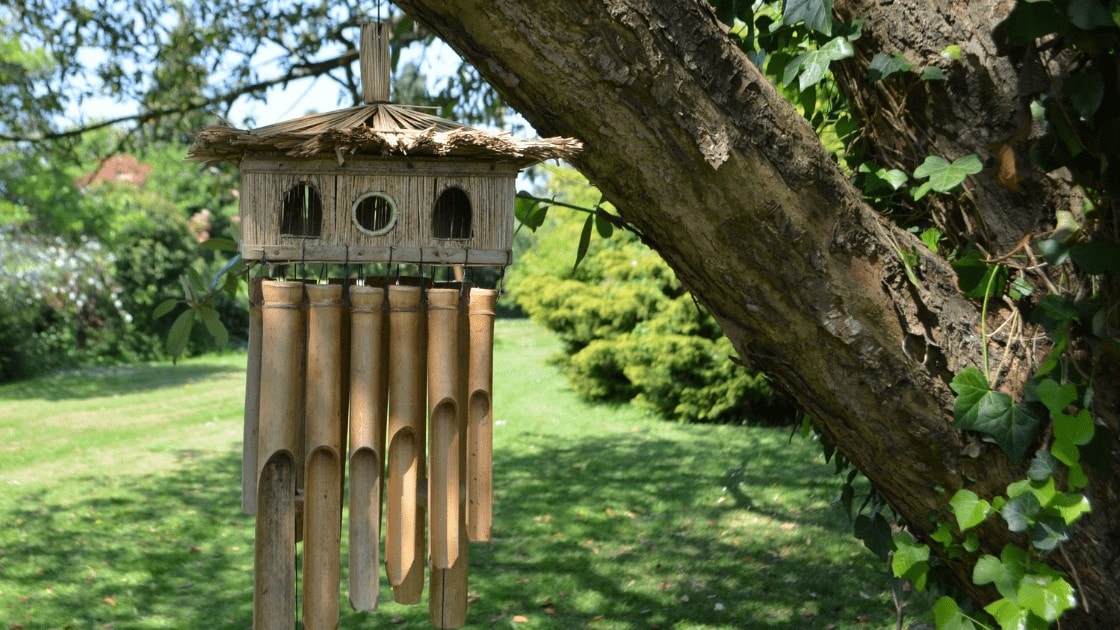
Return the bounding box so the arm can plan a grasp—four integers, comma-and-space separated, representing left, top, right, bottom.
188, 103, 581, 166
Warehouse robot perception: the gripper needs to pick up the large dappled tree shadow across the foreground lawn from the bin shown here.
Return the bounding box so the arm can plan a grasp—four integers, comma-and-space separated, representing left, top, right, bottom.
0, 427, 893, 629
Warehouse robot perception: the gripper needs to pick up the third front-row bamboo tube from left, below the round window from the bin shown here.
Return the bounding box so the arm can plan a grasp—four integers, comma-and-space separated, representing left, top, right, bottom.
349, 279, 389, 611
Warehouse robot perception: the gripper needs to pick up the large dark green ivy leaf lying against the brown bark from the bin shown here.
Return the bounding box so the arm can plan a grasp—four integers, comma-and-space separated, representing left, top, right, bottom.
949, 368, 1042, 462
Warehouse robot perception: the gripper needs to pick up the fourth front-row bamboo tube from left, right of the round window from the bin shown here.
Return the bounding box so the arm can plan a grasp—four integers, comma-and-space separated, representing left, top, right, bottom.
385, 286, 427, 604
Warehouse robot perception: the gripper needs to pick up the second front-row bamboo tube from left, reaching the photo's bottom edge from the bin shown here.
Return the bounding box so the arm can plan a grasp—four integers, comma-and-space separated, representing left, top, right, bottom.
304, 285, 344, 630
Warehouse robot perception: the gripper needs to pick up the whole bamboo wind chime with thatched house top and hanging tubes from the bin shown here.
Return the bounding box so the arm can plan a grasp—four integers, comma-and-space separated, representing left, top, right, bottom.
190, 24, 579, 630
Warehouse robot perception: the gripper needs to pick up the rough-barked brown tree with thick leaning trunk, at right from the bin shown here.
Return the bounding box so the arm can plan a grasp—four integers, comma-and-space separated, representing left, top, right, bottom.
389, 0, 1120, 627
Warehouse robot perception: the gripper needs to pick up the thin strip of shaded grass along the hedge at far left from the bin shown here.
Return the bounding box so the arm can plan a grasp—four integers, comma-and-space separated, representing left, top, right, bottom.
0, 359, 245, 400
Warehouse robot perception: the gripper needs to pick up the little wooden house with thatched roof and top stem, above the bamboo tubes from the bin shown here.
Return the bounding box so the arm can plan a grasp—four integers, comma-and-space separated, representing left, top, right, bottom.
190, 25, 579, 266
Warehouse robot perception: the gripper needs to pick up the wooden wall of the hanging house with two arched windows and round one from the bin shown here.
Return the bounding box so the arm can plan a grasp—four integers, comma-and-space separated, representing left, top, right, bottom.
241, 155, 517, 265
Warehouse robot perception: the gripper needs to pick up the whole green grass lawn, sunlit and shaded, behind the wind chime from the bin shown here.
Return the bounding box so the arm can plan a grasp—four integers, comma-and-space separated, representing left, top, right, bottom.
0, 321, 918, 629
